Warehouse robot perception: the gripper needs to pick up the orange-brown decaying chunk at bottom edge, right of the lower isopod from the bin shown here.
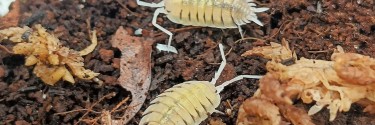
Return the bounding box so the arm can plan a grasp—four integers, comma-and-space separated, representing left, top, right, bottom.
237, 74, 314, 125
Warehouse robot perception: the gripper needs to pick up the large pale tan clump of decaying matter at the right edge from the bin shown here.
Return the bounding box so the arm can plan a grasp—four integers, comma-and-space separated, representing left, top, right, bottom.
238, 48, 375, 124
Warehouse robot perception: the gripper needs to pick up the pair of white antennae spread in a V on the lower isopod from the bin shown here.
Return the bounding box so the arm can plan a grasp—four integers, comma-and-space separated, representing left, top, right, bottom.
210, 44, 263, 93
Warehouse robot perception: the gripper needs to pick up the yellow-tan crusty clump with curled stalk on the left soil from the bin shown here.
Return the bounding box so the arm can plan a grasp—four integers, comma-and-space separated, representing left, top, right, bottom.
0, 25, 99, 85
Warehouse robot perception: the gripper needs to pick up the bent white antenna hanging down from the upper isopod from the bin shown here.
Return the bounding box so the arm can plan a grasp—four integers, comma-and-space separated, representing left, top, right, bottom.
152, 8, 177, 53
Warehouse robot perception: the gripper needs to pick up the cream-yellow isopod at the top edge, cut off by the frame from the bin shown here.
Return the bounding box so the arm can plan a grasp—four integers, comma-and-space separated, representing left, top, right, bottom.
137, 0, 268, 53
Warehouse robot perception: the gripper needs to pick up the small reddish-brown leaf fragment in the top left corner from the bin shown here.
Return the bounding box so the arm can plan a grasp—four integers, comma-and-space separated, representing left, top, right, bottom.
0, 0, 20, 29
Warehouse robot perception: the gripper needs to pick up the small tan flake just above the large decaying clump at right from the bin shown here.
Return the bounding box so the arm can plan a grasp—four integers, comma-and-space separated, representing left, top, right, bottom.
241, 39, 297, 62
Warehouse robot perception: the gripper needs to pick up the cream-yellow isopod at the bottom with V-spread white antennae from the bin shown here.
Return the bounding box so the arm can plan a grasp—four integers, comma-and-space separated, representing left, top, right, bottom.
139, 44, 261, 125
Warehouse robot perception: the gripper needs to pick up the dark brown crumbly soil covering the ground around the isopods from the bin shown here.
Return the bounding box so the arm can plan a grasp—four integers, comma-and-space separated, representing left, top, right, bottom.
0, 0, 375, 125
